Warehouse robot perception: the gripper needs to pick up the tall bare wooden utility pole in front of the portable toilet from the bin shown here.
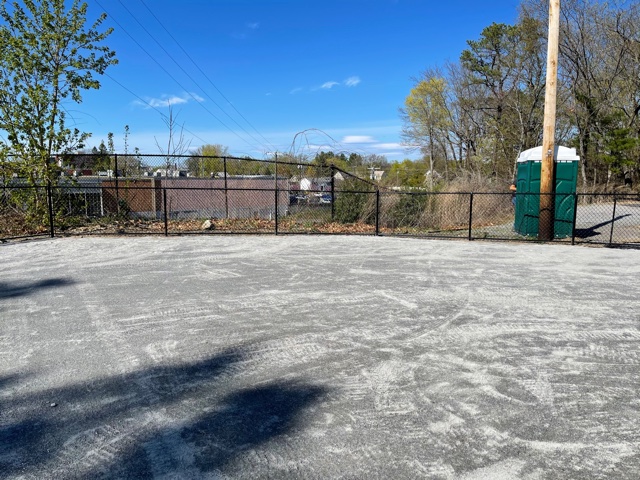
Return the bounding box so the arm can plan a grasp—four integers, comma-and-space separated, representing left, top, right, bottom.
538, 0, 560, 240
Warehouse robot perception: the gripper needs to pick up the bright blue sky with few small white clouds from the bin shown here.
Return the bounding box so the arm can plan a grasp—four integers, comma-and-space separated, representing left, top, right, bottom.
77, 0, 519, 161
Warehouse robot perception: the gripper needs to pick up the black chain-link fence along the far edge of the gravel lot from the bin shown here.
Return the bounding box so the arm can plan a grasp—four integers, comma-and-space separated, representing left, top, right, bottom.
0, 155, 640, 246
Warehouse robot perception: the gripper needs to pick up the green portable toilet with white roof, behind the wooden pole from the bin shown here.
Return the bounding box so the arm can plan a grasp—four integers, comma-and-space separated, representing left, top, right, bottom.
514, 147, 580, 238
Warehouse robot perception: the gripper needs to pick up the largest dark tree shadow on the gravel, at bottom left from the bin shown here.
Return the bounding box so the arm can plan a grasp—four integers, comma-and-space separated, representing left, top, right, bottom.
0, 350, 326, 478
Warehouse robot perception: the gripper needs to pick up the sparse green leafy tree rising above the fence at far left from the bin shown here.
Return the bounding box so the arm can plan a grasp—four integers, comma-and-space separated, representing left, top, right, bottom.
0, 0, 117, 182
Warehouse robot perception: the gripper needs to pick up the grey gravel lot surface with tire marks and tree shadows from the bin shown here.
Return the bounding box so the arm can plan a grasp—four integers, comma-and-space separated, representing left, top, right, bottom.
0, 236, 640, 480
